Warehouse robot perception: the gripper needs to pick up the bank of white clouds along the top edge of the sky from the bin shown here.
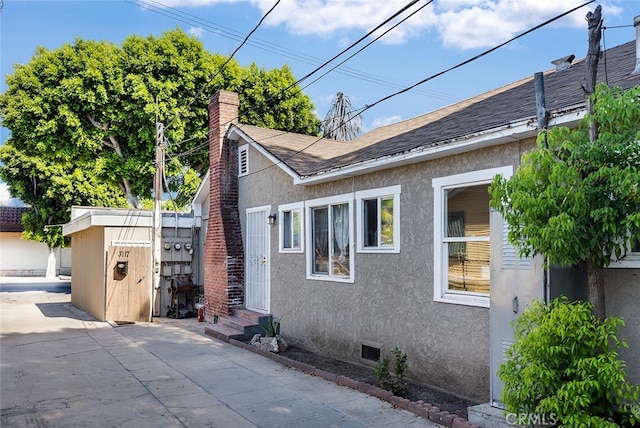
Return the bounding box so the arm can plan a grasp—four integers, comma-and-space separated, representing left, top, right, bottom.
149, 0, 622, 49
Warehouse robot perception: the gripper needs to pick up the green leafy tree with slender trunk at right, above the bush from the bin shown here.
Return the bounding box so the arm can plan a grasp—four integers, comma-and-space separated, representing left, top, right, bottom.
489, 84, 640, 319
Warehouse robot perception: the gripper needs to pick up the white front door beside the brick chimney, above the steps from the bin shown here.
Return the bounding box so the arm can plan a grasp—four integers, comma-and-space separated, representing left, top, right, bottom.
245, 206, 271, 313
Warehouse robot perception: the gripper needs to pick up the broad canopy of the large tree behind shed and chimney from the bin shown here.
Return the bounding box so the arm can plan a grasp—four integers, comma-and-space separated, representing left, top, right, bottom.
0, 29, 321, 248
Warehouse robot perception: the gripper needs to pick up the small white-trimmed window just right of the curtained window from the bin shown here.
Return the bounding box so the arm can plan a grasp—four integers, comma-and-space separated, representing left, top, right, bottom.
356, 186, 400, 253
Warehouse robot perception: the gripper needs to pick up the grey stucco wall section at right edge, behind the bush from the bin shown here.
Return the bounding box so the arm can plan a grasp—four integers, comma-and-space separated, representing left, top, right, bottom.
605, 269, 640, 385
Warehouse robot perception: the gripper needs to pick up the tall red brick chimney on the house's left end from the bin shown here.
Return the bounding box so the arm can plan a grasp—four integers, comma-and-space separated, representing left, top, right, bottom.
204, 91, 244, 322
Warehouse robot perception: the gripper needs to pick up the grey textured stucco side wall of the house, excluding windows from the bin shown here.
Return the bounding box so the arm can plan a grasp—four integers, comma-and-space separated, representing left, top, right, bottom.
239, 141, 531, 401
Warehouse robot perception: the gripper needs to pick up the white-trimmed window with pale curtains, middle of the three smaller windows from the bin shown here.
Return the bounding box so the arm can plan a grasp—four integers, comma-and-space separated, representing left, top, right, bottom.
305, 194, 353, 282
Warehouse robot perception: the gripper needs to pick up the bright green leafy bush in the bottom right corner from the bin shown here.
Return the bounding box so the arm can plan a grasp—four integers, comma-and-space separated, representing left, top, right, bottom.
498, 297, 639, 427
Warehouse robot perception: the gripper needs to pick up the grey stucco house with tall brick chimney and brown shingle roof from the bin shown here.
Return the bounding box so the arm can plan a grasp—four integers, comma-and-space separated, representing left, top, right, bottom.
198, 34, 640, 402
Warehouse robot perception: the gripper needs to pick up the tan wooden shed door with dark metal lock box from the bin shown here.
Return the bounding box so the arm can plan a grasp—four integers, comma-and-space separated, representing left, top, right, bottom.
105, 243, 152, 322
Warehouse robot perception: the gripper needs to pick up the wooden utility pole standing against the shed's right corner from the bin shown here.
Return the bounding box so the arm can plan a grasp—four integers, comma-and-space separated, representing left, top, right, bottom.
149, 122, 164, 322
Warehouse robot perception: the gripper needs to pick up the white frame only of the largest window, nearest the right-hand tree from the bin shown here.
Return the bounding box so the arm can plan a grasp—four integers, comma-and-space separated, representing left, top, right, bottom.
432, 166, 513, 308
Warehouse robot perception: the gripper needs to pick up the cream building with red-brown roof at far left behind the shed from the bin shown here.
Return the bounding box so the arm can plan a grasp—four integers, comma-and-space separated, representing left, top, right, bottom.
0, 207, 71, 277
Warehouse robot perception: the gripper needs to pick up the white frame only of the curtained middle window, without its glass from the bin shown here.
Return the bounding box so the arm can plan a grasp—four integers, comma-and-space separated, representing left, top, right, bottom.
304, 193, 355, 283
